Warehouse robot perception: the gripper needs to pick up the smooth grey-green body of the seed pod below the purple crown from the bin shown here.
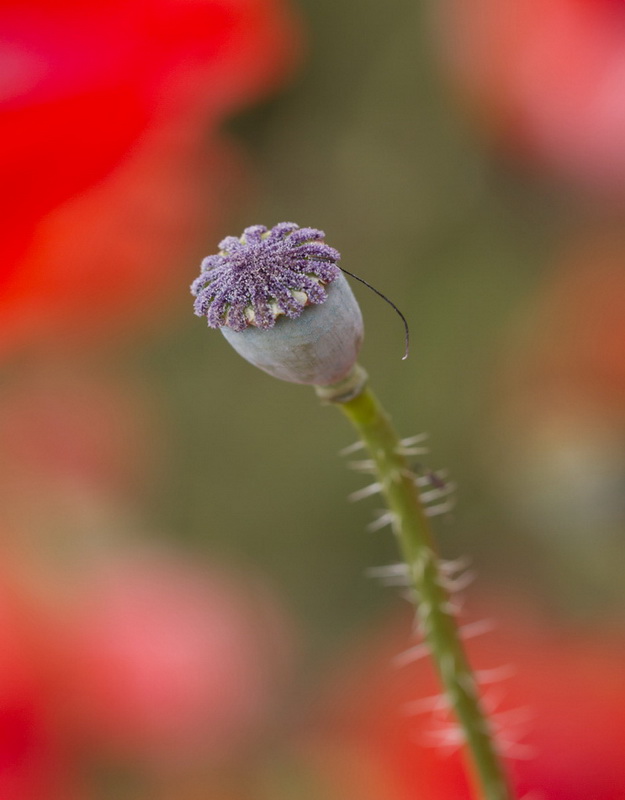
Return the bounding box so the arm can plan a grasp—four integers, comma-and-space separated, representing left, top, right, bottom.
221, 275, 363, 386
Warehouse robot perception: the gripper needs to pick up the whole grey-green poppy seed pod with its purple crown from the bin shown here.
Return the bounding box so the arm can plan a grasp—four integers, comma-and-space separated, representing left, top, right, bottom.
191, 222, 363, 386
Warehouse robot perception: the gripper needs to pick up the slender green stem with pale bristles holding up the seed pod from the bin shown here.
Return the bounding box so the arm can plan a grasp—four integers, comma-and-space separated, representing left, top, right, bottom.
319, 376, 513, 800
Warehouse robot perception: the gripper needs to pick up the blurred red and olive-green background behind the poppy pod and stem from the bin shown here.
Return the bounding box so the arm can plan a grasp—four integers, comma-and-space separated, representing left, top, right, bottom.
0, 0, 625, 800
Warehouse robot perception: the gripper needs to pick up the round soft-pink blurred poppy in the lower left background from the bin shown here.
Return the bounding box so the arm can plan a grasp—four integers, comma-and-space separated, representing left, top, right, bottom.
63, 553, 290, 769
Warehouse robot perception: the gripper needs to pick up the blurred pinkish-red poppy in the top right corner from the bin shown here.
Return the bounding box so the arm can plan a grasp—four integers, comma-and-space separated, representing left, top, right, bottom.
434, 0, 625, 197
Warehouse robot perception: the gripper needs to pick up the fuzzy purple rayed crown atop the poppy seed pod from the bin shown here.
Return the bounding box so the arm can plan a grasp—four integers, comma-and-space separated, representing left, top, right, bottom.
191, 222, 341, 331
